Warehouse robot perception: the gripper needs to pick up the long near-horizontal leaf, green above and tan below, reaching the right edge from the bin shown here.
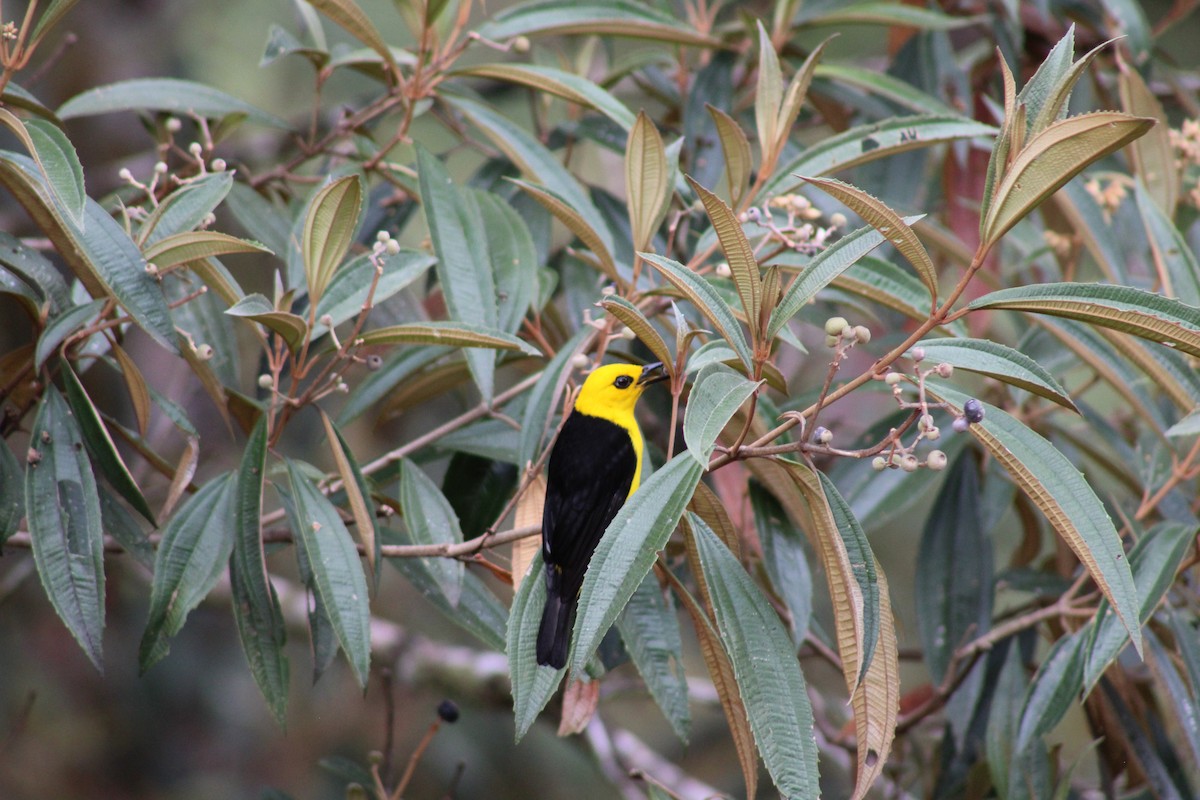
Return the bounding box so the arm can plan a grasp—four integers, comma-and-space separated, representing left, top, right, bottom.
970, 283, 1200, 356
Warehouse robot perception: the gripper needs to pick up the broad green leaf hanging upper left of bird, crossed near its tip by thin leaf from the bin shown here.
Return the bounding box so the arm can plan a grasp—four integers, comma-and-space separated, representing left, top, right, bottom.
416, 146, 499, 402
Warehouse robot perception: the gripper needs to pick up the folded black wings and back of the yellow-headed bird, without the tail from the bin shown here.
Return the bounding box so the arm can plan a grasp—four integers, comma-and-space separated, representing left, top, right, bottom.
542, 414, 637, 597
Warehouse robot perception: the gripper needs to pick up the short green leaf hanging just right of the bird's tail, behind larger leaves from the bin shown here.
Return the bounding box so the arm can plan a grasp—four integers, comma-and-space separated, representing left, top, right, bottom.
617, 575, 691, 744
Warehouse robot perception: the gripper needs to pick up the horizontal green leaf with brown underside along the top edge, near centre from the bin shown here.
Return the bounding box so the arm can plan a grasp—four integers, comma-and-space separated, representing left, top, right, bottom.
479, 0, 719, 47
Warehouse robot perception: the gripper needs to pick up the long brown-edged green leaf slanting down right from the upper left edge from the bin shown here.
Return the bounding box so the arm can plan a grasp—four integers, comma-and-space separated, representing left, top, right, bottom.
0, 151, 179, 353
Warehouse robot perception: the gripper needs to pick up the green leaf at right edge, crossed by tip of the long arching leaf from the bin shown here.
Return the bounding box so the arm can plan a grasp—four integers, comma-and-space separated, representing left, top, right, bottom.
1081, 522, 1196, 692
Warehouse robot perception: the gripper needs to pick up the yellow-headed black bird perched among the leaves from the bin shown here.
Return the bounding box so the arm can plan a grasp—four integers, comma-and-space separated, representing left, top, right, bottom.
538, 361, 670, 669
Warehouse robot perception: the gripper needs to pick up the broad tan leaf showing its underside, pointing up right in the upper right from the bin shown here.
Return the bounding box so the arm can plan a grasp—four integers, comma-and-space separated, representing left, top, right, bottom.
979, 112, 1154, 246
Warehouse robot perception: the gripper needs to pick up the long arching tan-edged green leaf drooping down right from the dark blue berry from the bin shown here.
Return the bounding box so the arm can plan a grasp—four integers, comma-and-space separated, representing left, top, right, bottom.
929, 384, 1141, 655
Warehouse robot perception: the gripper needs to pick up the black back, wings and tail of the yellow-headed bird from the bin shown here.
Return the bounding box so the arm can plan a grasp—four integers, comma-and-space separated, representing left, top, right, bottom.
538, 411, 637, 668
